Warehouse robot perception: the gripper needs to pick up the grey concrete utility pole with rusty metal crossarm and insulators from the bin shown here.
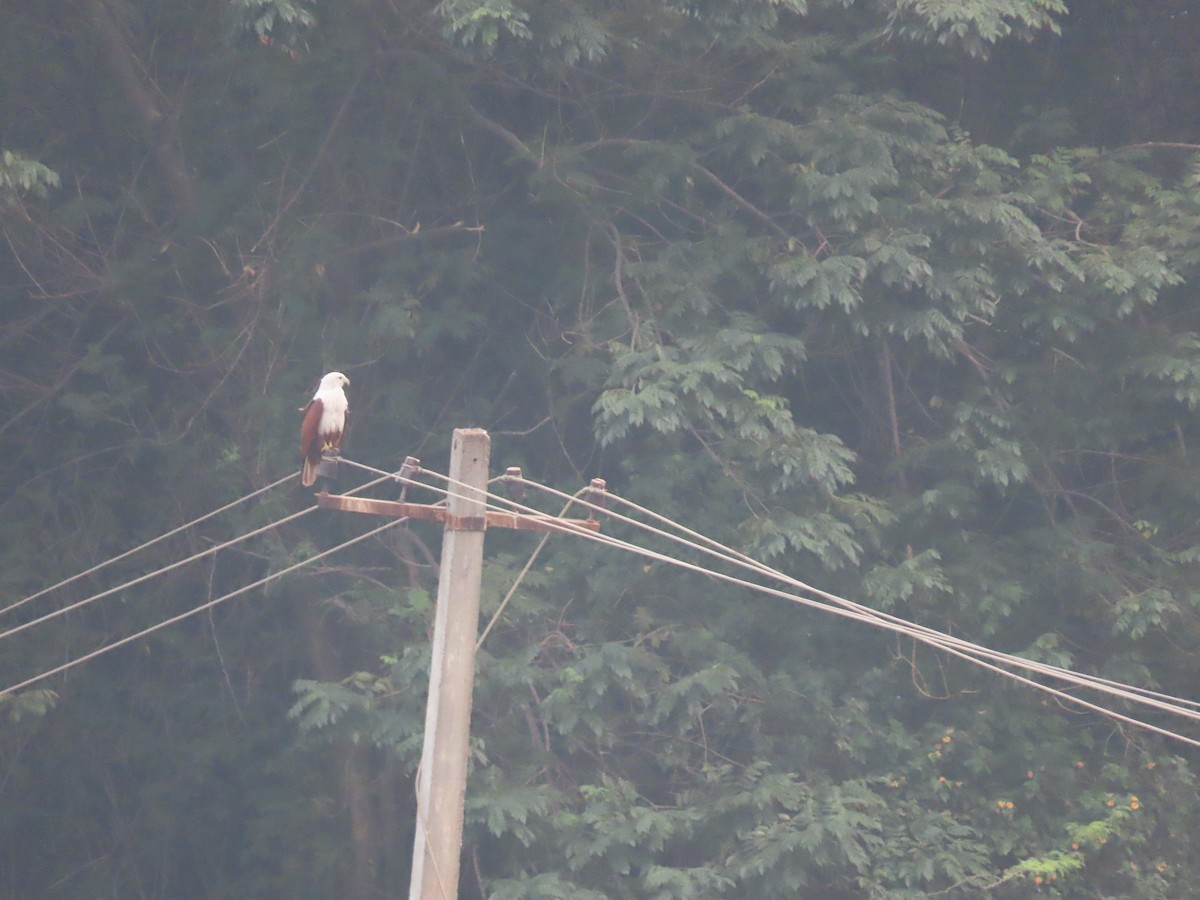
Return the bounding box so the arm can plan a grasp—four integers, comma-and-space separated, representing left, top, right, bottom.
317, 428, 605, 900
